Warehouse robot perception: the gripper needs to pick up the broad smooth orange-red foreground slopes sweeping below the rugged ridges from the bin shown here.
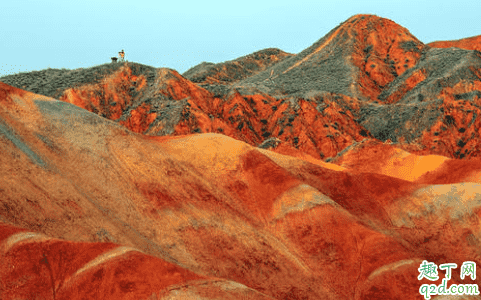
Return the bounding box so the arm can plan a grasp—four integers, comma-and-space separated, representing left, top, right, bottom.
0, 83, 481, 299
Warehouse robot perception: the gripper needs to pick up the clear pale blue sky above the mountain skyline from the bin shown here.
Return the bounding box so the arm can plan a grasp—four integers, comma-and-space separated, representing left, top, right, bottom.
0, 0, 481, 76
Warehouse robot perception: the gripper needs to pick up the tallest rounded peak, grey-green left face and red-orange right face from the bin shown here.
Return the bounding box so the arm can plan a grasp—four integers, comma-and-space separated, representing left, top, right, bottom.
240, 15, 426, 101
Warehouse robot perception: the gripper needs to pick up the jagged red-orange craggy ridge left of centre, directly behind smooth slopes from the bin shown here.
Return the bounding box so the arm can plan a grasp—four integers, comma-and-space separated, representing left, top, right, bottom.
0, 64, 369, 158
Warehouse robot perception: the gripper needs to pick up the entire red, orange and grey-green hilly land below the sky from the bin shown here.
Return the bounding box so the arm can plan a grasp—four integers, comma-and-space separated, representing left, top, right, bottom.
0, 15, 481, 299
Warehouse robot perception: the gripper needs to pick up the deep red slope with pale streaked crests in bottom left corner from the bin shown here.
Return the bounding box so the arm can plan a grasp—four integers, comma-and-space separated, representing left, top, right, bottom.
0, 223, 272, 300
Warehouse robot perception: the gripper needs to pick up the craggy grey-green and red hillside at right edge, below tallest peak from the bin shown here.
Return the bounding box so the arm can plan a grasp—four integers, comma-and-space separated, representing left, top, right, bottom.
359, 48, 481, 158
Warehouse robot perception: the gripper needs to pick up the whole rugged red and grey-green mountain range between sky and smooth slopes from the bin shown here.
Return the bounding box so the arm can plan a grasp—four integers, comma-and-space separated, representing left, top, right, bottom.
0, 15, 481, 159
